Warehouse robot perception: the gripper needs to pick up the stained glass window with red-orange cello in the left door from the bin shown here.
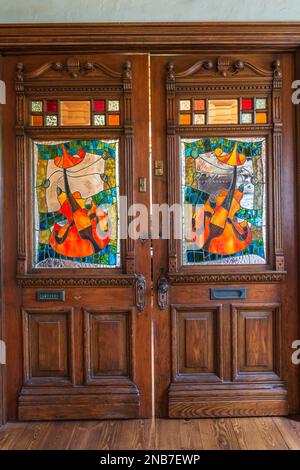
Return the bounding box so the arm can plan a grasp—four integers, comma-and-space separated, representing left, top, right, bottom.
33, 140, 120, 268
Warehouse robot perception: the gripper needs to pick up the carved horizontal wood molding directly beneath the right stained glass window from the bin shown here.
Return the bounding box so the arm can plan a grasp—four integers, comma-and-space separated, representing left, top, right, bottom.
168, 271, 286, 285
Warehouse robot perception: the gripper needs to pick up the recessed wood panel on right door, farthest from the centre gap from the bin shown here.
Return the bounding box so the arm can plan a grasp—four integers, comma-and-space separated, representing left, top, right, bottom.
232, 304, 280, 380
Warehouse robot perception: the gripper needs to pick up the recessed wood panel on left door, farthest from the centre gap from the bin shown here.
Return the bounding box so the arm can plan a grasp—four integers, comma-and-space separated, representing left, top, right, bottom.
23, 309, 73, 385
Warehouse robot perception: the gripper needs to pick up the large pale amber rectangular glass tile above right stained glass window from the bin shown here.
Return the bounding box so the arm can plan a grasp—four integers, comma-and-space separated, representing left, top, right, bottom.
208, 99, 238, 124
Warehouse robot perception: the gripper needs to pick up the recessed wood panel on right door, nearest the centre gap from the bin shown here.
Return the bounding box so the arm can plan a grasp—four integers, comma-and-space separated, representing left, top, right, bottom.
172, 305, 221, 380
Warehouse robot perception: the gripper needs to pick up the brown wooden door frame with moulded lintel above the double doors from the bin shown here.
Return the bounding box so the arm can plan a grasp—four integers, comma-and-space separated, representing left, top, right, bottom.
0, 22, 300, 424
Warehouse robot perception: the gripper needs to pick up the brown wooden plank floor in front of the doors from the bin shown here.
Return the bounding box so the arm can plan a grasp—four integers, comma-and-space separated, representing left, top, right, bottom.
0, 417, 300, 450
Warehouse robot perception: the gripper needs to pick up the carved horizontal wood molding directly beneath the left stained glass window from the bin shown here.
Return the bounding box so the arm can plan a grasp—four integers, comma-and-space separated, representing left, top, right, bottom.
17, 274, 135, 288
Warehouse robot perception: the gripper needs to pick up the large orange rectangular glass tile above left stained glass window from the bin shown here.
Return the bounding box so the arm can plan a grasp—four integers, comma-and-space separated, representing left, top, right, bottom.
60, 100, 91, 126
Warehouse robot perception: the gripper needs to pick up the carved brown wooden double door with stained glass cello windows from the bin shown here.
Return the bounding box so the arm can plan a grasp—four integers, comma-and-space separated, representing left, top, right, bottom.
3, 51, 298, 420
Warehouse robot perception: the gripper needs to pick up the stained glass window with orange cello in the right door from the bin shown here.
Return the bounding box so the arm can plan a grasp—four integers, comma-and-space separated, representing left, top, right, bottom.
181, 137, 266, 265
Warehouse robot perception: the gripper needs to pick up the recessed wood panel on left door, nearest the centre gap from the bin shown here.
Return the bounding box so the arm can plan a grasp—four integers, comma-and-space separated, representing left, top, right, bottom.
85, 310, 130, 382
